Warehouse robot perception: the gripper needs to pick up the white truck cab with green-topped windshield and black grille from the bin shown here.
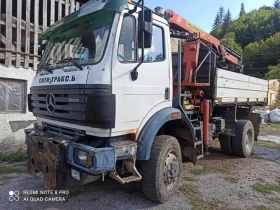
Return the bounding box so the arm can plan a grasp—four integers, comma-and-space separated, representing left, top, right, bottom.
31, 1, 172, 137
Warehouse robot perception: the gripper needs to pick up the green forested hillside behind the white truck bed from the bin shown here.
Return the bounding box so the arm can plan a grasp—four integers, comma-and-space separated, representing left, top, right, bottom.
211, 0, 280, 79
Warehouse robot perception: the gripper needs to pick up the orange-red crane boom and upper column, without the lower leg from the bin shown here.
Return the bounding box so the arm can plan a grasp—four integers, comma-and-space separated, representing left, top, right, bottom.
166, 10, 243, 87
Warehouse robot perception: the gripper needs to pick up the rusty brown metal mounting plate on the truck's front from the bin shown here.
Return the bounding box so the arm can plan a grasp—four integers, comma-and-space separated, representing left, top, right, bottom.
27, 135, 68, 190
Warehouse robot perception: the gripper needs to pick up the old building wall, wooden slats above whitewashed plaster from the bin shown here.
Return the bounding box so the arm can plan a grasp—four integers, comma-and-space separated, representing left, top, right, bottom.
0, 0, 85, 152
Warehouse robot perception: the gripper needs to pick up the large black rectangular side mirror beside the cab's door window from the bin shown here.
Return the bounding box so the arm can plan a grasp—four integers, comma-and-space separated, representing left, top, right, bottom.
138, 9, 153, 48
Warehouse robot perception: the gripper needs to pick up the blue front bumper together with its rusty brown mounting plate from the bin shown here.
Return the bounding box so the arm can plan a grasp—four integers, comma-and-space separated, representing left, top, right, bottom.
26, 132, 116, 189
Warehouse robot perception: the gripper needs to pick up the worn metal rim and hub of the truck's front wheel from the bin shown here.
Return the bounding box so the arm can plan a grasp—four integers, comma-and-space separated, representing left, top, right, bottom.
163, 152, 179, 189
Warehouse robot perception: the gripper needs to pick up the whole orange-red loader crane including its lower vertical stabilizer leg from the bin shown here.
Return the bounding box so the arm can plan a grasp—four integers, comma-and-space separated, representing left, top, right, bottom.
165, 10, 243, 153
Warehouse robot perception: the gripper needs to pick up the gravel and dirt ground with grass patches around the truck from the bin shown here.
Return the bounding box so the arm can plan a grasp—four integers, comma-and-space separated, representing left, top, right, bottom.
0, 142, 280, 210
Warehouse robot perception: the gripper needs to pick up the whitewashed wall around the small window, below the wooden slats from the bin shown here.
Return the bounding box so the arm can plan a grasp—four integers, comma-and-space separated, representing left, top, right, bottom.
0, 65, 36, 152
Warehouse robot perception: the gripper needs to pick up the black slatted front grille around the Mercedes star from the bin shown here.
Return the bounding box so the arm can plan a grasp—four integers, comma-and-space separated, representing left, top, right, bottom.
29, 85, 112, 124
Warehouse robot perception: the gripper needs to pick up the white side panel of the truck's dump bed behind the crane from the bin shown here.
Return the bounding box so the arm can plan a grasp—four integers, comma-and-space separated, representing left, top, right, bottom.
216, 69, 268, 105
